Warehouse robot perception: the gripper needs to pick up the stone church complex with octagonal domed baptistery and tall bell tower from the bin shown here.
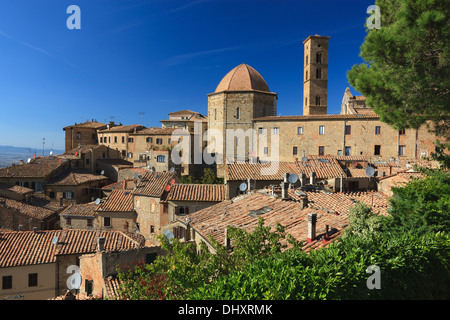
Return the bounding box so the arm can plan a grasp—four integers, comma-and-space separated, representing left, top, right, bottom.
208, 35, 442, 176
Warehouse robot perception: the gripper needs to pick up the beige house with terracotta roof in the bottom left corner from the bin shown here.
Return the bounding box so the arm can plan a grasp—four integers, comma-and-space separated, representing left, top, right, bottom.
0, 230, 144, 300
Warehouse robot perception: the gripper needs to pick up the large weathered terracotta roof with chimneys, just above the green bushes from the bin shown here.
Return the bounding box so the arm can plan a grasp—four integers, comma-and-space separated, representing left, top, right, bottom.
179, 190, 388, 246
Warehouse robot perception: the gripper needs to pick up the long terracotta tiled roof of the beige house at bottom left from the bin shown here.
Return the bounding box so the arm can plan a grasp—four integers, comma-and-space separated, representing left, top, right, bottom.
0, 229, 145, 268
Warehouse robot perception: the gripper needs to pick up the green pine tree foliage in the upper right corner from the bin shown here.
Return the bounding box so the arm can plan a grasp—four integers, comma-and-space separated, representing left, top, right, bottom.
347, 0, 450, 138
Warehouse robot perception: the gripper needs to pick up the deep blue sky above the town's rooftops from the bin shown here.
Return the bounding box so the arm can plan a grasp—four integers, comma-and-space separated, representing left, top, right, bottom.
0, 0, 375, 149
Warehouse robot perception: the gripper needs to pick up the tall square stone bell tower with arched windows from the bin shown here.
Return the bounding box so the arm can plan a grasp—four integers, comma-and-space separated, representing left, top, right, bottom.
303, 35, 330, 116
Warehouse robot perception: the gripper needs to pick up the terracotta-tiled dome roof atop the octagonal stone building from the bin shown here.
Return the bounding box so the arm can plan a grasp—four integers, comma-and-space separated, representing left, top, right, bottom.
215, 63, 270, 92
